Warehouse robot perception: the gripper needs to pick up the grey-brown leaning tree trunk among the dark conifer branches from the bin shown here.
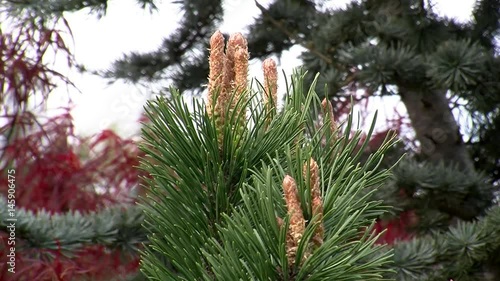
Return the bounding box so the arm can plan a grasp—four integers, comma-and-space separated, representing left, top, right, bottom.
399, 88, 474, 170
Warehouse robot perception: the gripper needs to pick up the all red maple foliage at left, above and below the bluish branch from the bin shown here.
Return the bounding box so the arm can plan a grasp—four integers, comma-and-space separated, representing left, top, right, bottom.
0, 19, 145, 281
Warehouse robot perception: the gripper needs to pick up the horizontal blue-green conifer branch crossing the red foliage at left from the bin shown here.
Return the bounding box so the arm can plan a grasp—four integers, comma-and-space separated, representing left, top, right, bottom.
0, 197, 147, 256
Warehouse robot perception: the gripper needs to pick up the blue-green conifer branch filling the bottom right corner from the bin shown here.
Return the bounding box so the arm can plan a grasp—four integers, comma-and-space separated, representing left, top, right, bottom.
391, 205, 500, 281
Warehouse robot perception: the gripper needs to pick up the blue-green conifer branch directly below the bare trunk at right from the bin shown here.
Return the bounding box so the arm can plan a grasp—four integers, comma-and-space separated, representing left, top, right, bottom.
374, 159, 497, 222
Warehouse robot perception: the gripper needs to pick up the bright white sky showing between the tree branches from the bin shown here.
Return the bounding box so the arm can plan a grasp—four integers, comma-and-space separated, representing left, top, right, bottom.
48, 0, 474, 137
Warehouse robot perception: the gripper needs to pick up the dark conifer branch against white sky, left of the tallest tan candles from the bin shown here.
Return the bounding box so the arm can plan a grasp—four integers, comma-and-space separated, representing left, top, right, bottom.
101, 0, 223, 90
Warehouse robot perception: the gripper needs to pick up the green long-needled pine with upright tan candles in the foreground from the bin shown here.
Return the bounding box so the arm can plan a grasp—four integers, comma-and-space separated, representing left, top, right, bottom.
141, 29, 393, 280
